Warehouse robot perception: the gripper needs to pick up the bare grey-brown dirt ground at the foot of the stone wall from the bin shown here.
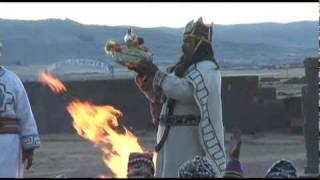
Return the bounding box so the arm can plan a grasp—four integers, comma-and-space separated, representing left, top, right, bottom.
25, 130, 314, 178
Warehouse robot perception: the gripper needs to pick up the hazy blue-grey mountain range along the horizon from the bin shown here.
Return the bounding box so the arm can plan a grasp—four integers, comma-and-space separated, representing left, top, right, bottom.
0, 19, 318, 65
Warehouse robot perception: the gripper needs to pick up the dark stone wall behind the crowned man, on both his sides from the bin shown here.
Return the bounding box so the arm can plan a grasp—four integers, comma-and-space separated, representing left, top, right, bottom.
24, 76, 300, 133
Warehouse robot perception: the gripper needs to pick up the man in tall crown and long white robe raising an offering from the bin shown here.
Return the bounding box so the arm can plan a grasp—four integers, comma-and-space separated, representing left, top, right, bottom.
130, 18, 226, 178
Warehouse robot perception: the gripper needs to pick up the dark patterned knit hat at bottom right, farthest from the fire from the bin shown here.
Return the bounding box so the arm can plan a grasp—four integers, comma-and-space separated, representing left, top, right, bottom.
265, 159, 297, 178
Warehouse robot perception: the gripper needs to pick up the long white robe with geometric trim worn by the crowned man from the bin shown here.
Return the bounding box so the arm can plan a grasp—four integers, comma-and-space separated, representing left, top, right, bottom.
149, 60, 227, 178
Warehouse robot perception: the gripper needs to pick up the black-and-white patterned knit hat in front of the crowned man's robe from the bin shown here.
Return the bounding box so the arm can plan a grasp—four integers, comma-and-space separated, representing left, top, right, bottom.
178, 156, 215, 178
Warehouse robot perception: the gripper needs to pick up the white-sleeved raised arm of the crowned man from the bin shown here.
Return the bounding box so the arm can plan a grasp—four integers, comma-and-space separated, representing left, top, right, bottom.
153, 70, 194, 102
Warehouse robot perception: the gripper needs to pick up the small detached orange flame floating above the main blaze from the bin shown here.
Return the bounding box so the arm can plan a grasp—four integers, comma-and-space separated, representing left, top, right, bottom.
39, 70, 67, 93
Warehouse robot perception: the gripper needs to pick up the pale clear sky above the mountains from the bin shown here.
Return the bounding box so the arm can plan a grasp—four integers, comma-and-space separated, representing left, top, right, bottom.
0, 2, 319, 28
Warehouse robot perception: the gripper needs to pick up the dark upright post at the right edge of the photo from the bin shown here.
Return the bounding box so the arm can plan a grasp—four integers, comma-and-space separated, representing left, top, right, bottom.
302, 58, 319, 175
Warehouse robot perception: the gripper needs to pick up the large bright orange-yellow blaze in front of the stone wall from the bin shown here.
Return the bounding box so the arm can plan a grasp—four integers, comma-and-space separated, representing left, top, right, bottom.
67, 100, 145, 178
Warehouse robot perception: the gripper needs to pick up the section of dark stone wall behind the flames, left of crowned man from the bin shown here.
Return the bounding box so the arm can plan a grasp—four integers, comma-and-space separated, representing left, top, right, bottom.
24, 80, 150, 133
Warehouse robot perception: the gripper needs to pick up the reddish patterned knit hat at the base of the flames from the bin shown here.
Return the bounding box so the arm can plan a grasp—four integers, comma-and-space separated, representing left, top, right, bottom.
127, 153, 154, 178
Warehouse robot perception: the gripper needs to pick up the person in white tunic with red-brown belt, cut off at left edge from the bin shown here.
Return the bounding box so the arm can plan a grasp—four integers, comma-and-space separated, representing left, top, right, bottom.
0, 40, 40, 178
